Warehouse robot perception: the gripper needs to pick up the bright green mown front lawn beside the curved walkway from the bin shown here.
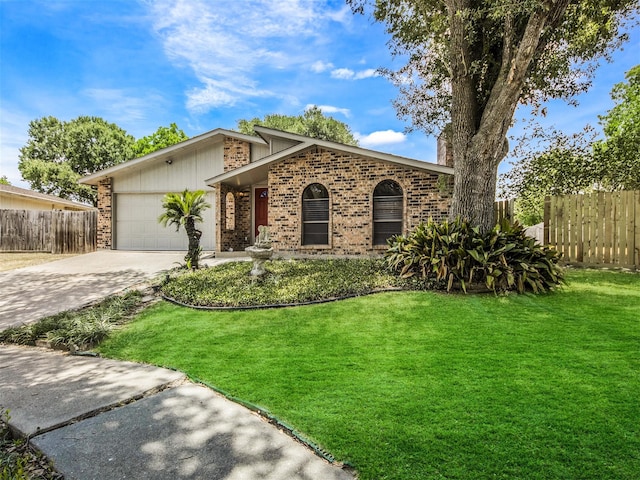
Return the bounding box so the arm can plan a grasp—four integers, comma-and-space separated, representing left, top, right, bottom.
101, 271, 640, 479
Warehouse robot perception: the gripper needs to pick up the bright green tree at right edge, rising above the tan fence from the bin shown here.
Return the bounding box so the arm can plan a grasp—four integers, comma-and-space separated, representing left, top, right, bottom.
593, 65, 640, 190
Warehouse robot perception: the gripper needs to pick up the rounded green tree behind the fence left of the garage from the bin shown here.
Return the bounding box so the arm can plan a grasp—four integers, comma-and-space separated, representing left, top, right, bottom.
18, 116, 134, 205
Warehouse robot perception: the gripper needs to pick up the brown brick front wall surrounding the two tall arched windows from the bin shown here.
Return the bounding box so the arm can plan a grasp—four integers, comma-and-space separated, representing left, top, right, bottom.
269, 149, 452, 255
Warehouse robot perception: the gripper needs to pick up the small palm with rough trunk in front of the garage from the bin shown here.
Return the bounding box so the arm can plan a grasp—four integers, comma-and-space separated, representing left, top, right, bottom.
158, 189, 211, 269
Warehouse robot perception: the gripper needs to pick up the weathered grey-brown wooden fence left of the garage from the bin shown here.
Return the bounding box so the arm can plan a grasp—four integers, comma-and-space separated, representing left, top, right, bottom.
0, 210, 98, 253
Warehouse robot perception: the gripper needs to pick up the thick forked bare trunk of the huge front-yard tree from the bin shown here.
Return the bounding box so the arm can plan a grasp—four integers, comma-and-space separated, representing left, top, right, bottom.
446, 0, 569, 233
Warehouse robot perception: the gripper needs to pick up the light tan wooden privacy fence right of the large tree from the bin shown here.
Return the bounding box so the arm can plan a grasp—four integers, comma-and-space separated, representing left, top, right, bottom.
544, 191, 640, 268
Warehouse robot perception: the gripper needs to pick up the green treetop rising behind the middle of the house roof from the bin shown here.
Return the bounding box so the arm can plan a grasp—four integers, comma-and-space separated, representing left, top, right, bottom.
238, 106, 358, 145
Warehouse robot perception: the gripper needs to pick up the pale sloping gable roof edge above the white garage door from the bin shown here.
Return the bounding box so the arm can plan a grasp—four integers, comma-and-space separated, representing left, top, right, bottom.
79, 128, 266, 185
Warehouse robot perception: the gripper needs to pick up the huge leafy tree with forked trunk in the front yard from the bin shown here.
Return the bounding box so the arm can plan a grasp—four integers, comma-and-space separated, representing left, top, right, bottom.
347, 0, 638, 231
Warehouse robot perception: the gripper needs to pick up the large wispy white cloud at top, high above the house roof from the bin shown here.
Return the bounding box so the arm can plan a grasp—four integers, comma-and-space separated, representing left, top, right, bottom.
150, 0, 350, 112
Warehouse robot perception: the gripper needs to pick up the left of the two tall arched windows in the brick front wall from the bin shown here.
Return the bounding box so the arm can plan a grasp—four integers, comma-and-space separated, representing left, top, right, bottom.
302, 183, 329, 245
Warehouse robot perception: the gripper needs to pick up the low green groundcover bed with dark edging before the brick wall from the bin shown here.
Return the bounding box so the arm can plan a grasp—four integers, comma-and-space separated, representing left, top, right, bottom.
162, 259, 408, 307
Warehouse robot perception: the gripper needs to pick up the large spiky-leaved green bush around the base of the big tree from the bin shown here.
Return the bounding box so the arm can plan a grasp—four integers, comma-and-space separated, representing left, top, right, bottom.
385, 219, 563, 293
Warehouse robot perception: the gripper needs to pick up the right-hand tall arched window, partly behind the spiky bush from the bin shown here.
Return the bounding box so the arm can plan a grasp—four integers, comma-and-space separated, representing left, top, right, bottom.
373, 180, 403, 245
